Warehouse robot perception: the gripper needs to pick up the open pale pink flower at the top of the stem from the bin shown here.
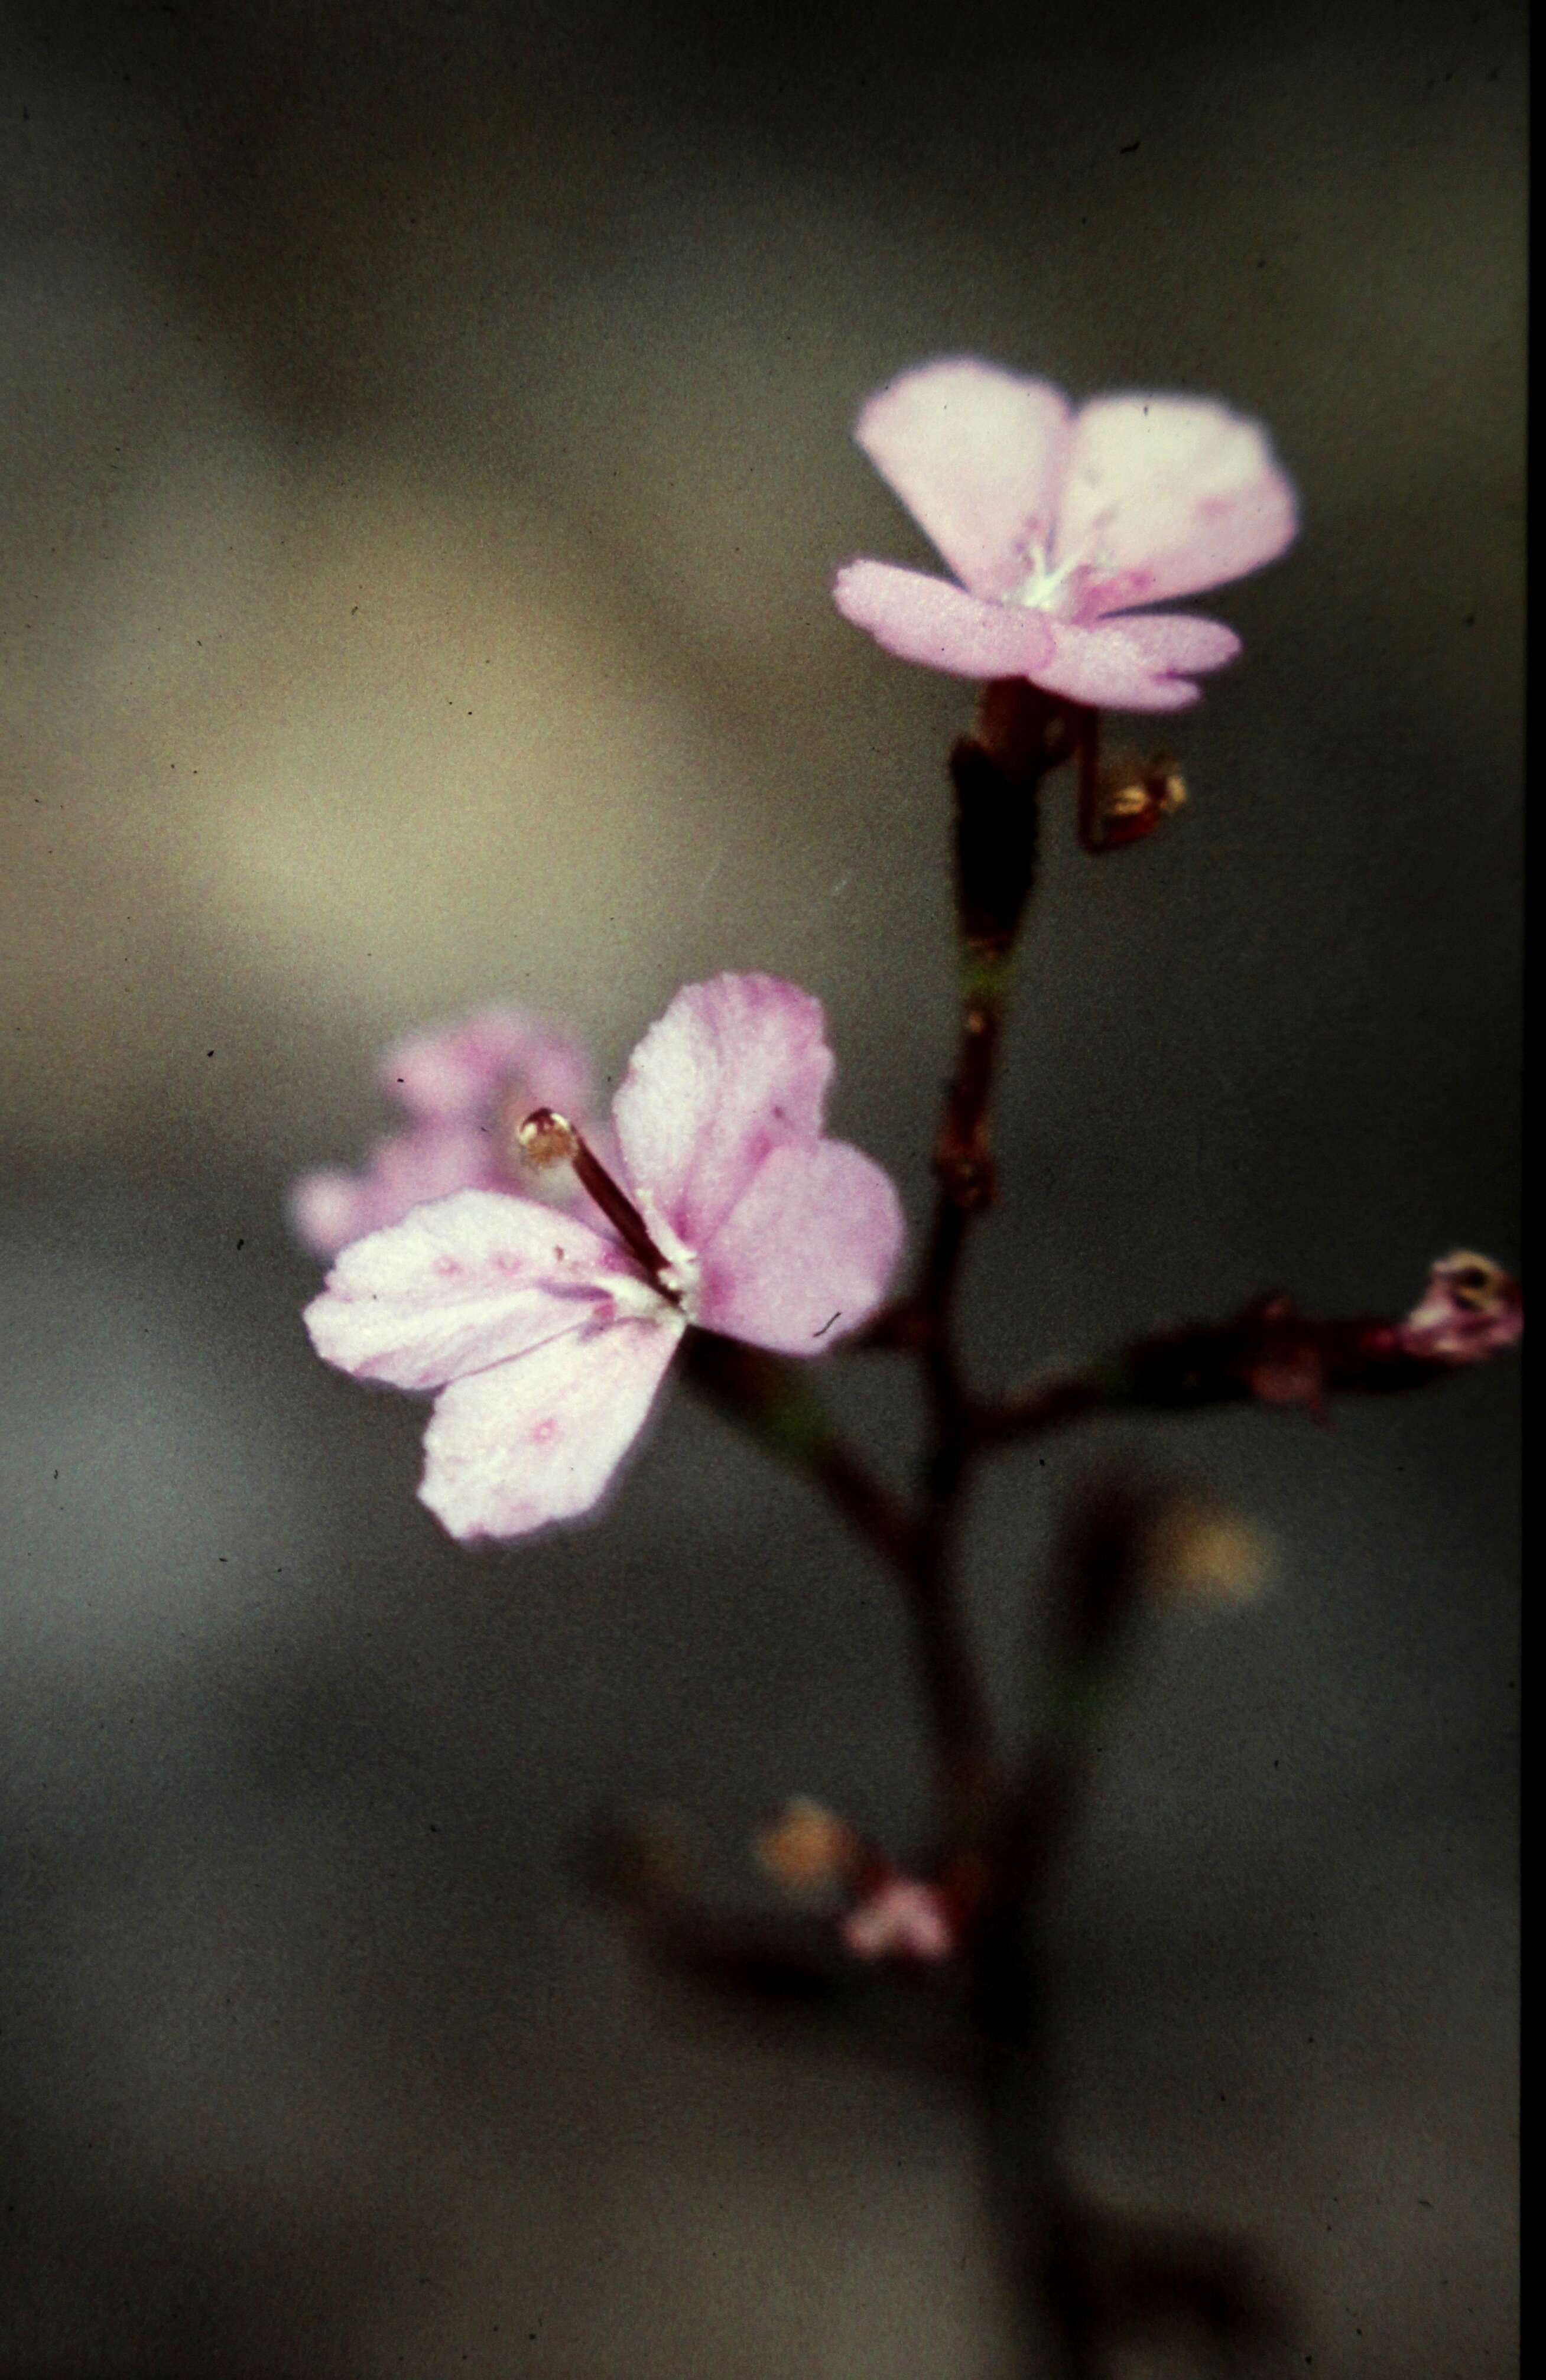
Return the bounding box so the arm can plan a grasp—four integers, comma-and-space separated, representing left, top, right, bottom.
834, 357, 1298, 711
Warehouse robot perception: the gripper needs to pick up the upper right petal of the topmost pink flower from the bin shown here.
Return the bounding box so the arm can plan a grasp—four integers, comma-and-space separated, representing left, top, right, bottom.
1053, 398, 1298, 616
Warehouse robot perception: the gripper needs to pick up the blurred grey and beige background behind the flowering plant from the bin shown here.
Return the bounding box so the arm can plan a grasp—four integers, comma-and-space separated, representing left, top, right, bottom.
0, 0, 1525, 2380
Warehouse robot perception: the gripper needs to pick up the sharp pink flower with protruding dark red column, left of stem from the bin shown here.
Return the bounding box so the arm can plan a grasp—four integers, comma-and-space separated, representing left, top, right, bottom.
305, 976, 903, 1540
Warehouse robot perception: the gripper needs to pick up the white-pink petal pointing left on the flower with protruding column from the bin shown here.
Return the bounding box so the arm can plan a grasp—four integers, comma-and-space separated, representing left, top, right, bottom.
305, 1190, 638, 1387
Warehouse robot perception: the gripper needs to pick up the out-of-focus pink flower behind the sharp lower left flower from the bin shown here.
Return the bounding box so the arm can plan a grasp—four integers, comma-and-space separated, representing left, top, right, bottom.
291, 1009, 591, 1257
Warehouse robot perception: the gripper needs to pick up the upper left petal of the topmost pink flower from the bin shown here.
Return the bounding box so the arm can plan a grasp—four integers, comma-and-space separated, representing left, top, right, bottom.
855, 357, 1067, 595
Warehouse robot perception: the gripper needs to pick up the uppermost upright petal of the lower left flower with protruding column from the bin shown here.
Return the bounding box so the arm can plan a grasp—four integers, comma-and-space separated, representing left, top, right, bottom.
612, 976, 832, 1250
